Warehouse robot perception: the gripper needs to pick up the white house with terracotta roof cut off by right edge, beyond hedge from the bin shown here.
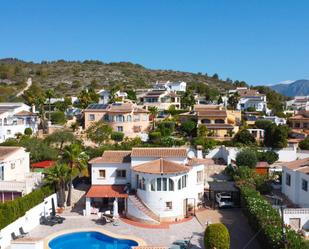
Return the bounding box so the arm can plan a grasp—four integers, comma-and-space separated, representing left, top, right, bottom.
282, 158, 309, 208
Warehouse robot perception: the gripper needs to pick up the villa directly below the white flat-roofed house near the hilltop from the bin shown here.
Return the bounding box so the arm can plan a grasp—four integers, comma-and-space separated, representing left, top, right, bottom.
140, 90, 180, 111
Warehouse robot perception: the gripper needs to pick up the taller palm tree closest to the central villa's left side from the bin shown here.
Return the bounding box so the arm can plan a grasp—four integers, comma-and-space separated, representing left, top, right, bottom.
63, 143, 89, 206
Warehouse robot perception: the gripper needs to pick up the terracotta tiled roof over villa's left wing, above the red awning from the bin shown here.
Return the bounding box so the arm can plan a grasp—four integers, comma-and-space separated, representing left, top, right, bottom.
89, 150, 131, 163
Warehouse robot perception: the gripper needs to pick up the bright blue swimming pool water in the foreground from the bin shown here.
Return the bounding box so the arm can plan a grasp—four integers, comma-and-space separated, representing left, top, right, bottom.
48, 232, 138, 249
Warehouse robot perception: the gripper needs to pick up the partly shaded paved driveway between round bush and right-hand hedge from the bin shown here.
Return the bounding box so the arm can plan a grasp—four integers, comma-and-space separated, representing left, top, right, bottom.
196, 208, 261, 249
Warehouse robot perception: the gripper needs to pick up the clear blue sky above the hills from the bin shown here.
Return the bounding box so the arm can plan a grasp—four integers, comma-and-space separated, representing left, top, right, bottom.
0, 0, 309, 85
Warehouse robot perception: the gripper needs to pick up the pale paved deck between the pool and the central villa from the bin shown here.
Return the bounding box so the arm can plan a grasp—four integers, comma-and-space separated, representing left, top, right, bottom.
30, 216, 205, 249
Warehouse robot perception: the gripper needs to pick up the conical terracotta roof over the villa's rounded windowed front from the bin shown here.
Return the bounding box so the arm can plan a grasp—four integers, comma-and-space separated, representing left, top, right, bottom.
133, 158, 189, 174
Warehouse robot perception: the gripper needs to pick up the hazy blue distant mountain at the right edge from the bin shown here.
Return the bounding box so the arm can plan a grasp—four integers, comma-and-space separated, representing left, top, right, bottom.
270, 80, 309, 97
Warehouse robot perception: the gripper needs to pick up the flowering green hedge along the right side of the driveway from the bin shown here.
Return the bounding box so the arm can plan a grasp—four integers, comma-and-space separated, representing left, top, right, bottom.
240, 185, 309, 249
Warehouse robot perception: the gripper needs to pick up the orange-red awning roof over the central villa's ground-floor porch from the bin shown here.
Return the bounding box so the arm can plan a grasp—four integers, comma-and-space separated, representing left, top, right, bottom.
86, 185, 128, 198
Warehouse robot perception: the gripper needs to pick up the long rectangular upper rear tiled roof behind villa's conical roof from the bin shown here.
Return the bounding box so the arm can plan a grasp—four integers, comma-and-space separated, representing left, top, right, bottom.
131, 148, 187, 158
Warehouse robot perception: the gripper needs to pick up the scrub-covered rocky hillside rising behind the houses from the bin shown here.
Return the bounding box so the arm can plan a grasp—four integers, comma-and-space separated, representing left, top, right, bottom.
0, 59, 232, 101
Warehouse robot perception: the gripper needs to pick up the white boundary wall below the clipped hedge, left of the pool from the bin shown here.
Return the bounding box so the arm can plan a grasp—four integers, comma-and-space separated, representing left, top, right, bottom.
0, 194, 57, 248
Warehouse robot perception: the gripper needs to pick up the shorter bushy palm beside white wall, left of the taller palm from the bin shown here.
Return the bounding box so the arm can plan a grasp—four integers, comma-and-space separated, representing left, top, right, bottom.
44, 163, 70, 207
